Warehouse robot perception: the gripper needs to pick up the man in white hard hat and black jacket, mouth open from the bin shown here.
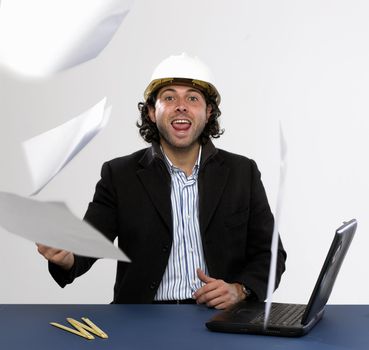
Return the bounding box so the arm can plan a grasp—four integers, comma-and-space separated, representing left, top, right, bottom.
38, 54, 286, 309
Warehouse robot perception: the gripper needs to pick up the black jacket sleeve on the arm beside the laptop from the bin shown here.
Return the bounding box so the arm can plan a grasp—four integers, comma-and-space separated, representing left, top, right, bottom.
240, 161, 287, 300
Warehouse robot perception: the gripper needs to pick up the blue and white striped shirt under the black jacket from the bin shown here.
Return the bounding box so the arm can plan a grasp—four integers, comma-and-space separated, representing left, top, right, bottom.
155, 148, 208, 300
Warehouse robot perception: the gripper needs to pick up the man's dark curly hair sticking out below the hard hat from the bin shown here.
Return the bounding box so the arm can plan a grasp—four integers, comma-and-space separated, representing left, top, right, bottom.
136, 91, 224, 145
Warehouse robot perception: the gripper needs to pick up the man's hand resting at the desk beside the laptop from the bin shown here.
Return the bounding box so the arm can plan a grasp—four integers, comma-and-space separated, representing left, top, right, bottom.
193, 269, 245, 309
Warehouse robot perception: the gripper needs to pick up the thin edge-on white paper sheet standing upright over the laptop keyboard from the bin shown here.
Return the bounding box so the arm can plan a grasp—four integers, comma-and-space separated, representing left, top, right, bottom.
264, 124, 287, 328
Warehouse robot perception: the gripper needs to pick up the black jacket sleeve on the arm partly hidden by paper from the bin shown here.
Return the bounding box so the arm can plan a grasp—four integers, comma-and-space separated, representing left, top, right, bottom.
49, 162, 117, 287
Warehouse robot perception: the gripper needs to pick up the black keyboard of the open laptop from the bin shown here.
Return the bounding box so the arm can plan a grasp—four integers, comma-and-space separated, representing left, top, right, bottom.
250, 304, 306, 326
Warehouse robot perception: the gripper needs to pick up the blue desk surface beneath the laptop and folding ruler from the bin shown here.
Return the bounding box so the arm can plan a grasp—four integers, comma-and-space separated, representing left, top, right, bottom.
0, 305, 369, 350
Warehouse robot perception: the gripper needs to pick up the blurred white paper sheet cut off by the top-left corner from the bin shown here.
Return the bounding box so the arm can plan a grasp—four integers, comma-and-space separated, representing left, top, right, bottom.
0, 0, 133, 77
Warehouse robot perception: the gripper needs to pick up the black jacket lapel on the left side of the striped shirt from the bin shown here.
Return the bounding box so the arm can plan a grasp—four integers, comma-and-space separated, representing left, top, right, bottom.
137, 149, 173, 232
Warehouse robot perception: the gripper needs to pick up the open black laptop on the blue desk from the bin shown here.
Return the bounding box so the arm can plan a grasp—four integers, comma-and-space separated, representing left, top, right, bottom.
206, 219, 357, 337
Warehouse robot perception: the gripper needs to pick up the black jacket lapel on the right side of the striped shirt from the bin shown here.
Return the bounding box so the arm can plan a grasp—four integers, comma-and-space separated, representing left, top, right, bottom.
199, 155, 229, 235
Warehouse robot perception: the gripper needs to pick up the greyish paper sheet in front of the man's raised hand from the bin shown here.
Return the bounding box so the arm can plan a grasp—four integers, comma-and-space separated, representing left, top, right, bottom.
0, 192, 130, 262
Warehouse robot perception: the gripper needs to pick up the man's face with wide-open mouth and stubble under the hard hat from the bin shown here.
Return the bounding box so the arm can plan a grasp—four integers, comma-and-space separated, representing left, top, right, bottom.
149, 84, 211, 150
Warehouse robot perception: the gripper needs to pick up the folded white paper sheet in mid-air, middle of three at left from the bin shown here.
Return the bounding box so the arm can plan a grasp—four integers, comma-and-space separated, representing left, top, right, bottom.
22, 98, 111, 195
